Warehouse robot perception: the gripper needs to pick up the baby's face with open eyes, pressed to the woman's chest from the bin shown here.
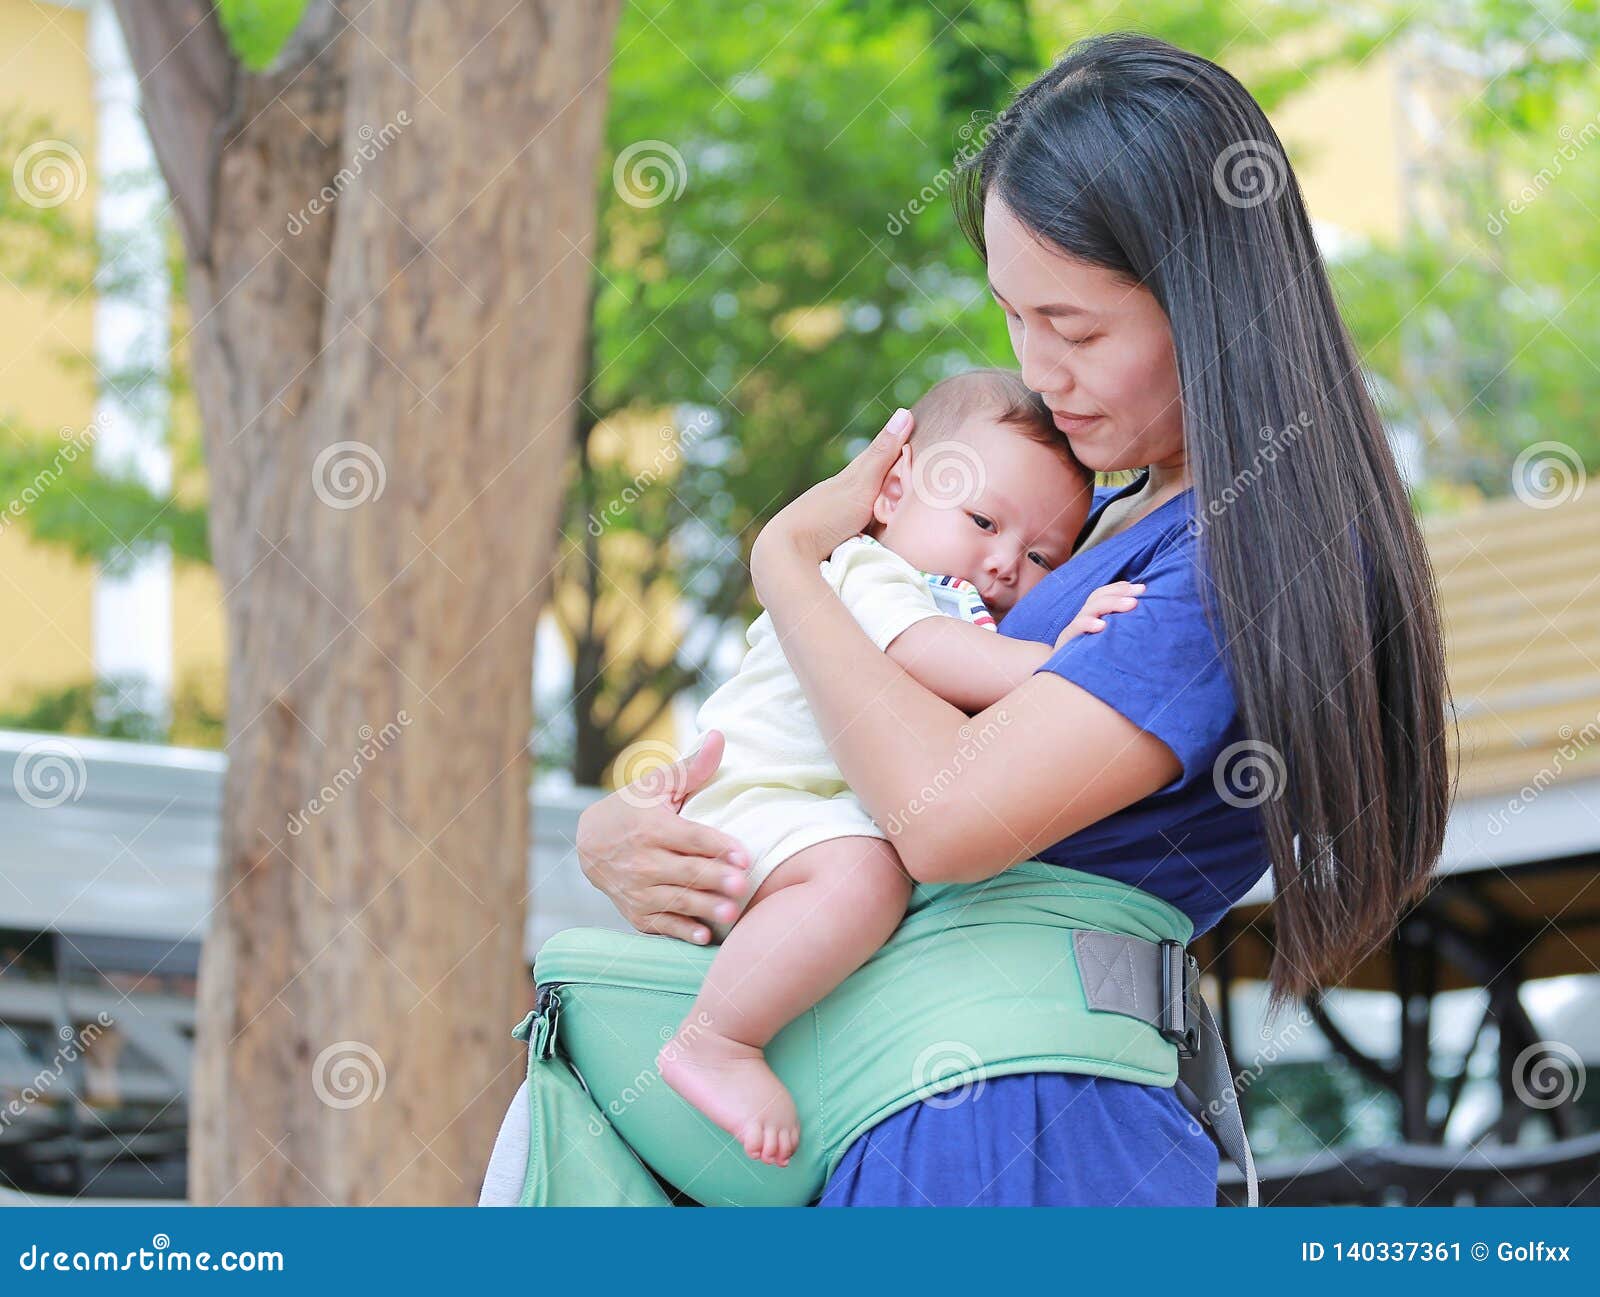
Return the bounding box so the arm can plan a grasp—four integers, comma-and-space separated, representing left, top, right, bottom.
872, 419, 1093, 616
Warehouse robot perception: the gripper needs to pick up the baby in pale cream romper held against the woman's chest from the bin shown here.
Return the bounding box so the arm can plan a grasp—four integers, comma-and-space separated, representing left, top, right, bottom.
656, 369, 1134, 1166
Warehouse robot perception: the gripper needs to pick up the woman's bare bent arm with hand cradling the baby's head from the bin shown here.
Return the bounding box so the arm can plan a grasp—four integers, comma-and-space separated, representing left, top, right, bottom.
750, 411, 1181, 883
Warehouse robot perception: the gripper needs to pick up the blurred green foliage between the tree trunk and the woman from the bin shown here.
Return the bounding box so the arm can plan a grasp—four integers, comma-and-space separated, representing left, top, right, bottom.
562, 0, 1376, 782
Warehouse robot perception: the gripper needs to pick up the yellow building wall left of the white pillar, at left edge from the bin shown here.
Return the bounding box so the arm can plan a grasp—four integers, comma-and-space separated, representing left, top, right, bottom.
0, 0, 94, 704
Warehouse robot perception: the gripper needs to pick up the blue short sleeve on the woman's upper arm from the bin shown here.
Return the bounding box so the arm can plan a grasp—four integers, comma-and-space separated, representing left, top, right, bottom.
1038, 542, 1238, 787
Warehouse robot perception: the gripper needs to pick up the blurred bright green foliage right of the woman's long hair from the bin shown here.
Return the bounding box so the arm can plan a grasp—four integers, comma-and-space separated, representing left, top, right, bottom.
1334, 0, 1600, 509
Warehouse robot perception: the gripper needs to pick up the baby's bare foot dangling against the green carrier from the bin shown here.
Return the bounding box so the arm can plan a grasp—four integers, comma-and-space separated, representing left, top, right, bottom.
656, 1025, 800, 1166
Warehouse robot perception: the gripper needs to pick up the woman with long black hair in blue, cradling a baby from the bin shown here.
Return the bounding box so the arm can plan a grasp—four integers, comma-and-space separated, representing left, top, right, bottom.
483, 35, 1450, 1206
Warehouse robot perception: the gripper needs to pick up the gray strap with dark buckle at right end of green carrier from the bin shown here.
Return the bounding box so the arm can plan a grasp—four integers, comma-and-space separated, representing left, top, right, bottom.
1072, 928, 1261, 1207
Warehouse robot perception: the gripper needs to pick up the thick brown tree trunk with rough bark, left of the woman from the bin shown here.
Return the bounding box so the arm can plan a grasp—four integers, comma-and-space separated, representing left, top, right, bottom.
117, 0, 618, 1204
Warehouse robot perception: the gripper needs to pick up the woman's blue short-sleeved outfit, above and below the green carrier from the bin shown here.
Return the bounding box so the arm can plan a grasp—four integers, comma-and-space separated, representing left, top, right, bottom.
822, 480, 1267, 1206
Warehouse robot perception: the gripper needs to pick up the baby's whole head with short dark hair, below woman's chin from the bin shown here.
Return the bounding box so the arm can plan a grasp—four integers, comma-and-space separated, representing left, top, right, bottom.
869, 369, 1094, 616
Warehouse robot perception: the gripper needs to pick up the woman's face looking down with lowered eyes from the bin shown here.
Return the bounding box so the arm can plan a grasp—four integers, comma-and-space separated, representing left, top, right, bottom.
984, 192, 1184, 472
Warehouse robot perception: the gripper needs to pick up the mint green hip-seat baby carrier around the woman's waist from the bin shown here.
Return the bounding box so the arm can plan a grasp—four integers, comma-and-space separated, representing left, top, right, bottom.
512, 860, 1258, 1206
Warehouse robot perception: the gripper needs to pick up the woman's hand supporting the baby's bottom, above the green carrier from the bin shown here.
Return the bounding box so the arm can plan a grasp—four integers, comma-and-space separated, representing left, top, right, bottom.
578, 731, 750, 945
